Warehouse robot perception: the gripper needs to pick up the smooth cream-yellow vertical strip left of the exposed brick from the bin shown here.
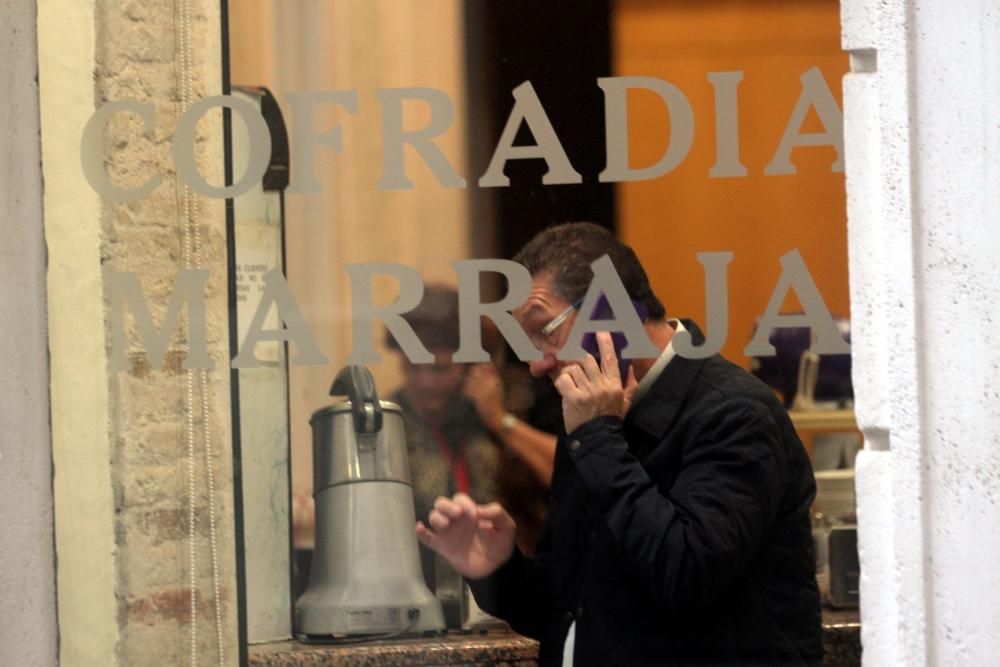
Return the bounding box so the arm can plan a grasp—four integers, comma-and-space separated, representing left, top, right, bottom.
38, 0, 119, 667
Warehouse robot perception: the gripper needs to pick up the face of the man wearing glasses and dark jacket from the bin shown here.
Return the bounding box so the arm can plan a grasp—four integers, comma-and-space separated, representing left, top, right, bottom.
514, 273, 577, 380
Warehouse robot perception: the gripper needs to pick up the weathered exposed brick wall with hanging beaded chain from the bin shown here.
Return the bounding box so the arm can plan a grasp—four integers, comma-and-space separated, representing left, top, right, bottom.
94, 0, 238, 665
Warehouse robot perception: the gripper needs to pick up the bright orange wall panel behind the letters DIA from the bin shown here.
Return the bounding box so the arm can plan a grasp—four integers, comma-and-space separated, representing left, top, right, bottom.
613, 0, 848, 365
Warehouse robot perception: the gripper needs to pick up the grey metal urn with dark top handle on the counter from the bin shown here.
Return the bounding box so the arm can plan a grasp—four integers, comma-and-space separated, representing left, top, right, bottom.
295, 366, 445, 641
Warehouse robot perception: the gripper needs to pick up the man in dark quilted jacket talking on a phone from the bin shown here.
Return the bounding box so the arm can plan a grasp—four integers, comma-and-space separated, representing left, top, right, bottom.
417, 224, 822, 667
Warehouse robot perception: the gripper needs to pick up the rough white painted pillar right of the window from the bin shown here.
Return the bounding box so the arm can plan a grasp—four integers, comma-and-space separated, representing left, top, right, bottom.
842, 0, 1000, 666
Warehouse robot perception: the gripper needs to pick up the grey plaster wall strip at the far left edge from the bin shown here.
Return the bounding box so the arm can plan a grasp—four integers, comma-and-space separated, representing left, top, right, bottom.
0, 0, 56, 667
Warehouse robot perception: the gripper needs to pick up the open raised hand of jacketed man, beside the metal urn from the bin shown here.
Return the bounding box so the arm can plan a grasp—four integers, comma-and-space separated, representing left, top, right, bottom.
417, 493, 517, 579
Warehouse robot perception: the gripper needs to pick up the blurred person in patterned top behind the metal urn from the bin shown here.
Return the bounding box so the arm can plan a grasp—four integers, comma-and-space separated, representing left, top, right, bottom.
386, 285, 555, 590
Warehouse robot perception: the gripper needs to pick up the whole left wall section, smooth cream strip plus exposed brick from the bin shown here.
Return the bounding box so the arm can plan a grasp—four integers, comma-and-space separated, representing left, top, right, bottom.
39, 0, 238, 665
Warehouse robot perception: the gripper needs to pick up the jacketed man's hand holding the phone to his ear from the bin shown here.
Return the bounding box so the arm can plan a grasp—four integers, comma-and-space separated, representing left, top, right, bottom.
554, 331, 639, 433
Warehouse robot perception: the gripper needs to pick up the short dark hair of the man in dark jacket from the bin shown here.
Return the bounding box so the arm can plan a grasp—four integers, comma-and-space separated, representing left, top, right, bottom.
514, 222, 666, 320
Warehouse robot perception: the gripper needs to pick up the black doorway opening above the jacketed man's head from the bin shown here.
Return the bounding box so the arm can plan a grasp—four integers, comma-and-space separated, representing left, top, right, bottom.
466, 0, 615, 257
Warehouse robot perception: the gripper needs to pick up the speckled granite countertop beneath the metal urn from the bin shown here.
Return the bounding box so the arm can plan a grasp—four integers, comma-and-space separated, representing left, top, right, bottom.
249, 608, 861, 667
